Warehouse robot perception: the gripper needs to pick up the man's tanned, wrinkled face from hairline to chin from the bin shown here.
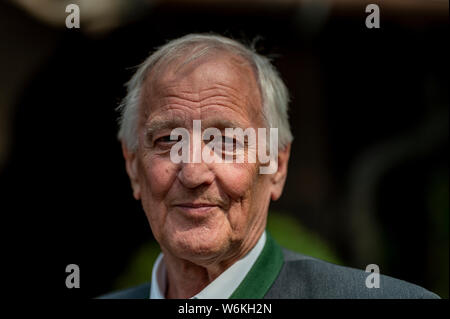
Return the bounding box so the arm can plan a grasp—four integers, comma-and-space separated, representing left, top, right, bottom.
124, 54, 284, 265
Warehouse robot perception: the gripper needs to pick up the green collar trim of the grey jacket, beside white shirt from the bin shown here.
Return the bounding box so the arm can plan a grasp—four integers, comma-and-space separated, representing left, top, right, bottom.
230, 231, 284, 299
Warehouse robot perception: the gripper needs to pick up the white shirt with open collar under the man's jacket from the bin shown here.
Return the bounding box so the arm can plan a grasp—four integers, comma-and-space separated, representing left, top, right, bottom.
150, 231, 266, 299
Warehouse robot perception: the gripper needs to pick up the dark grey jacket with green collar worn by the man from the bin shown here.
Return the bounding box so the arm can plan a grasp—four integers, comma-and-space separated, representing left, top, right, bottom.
100, 234, 439, 299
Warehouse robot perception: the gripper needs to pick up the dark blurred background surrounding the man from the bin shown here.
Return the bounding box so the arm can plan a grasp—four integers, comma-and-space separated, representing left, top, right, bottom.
0, 1, 449, 298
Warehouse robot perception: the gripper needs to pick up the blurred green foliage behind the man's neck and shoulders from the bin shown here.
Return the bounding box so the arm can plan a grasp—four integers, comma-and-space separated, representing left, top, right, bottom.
113, 212, 339, 290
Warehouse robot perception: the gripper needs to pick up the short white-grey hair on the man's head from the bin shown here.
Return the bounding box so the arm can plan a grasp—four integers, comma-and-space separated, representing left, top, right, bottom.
117, 34, 293, 152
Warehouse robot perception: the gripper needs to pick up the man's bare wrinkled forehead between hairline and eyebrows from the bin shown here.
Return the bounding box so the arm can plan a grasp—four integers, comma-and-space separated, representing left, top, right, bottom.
141, 52, 261, 125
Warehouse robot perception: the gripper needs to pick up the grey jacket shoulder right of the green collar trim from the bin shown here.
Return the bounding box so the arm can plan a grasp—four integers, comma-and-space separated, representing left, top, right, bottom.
266, 249, 439, 299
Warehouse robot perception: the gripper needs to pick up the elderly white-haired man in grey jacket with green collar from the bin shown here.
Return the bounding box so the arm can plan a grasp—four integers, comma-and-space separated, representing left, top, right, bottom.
103, 34, 437, 298
